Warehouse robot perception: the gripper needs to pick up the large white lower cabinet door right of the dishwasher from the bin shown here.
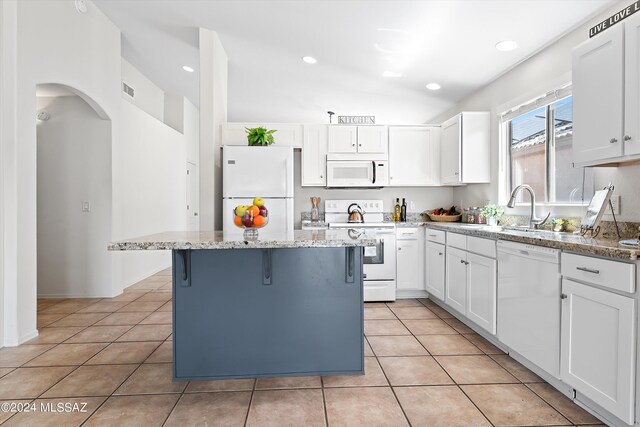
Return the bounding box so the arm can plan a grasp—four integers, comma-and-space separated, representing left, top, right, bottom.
560, 278, 636, 424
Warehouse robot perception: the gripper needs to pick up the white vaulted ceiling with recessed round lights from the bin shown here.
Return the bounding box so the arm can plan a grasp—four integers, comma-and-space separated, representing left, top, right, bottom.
94, 0, 615, 122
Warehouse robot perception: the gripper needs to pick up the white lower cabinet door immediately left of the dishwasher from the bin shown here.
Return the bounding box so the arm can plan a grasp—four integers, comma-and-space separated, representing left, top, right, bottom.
467, 253, 497, 335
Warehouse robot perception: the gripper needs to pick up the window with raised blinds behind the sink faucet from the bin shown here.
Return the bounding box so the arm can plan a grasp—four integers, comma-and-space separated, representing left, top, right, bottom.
500, 86, 594, 205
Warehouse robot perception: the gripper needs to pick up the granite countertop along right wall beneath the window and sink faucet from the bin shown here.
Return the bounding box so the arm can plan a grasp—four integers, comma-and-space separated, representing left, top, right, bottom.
422, 221, 640, 261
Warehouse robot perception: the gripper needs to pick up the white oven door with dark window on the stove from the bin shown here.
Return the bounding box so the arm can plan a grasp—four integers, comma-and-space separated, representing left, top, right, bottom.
363, 228, 396, 281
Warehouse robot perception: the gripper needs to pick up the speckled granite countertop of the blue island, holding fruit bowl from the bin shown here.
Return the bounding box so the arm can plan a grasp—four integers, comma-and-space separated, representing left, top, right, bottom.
108, 229, 379, 251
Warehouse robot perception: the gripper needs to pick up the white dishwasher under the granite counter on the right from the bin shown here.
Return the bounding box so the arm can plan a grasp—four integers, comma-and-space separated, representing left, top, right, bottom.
497, 240, 561, 378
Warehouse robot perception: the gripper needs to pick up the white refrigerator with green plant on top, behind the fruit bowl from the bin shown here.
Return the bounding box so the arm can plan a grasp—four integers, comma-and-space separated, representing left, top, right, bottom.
222, 145, 293, 236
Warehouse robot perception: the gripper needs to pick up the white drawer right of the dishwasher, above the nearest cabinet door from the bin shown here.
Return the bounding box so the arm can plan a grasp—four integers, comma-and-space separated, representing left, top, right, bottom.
561, 253, 636, 293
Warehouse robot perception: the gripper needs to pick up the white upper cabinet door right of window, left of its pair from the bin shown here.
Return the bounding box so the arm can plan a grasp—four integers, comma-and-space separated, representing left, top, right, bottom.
572, 25, 624, 165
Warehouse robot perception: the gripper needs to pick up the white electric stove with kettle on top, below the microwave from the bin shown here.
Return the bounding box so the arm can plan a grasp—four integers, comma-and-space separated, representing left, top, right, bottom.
324, 200, 396, 301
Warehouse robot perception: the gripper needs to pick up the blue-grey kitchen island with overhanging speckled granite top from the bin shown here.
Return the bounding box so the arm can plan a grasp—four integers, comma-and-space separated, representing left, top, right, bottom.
109, 230, 378, 379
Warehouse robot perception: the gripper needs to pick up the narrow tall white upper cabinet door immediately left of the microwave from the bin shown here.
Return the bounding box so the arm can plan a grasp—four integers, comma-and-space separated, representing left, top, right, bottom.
301, 125, 328, 187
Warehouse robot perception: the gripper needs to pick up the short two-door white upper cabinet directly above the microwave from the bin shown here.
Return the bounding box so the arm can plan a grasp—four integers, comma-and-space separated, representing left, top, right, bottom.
329, 125, 388, 155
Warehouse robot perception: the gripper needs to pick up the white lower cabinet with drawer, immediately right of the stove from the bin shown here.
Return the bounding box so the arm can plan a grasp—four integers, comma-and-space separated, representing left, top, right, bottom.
396, 227, 425, 291
